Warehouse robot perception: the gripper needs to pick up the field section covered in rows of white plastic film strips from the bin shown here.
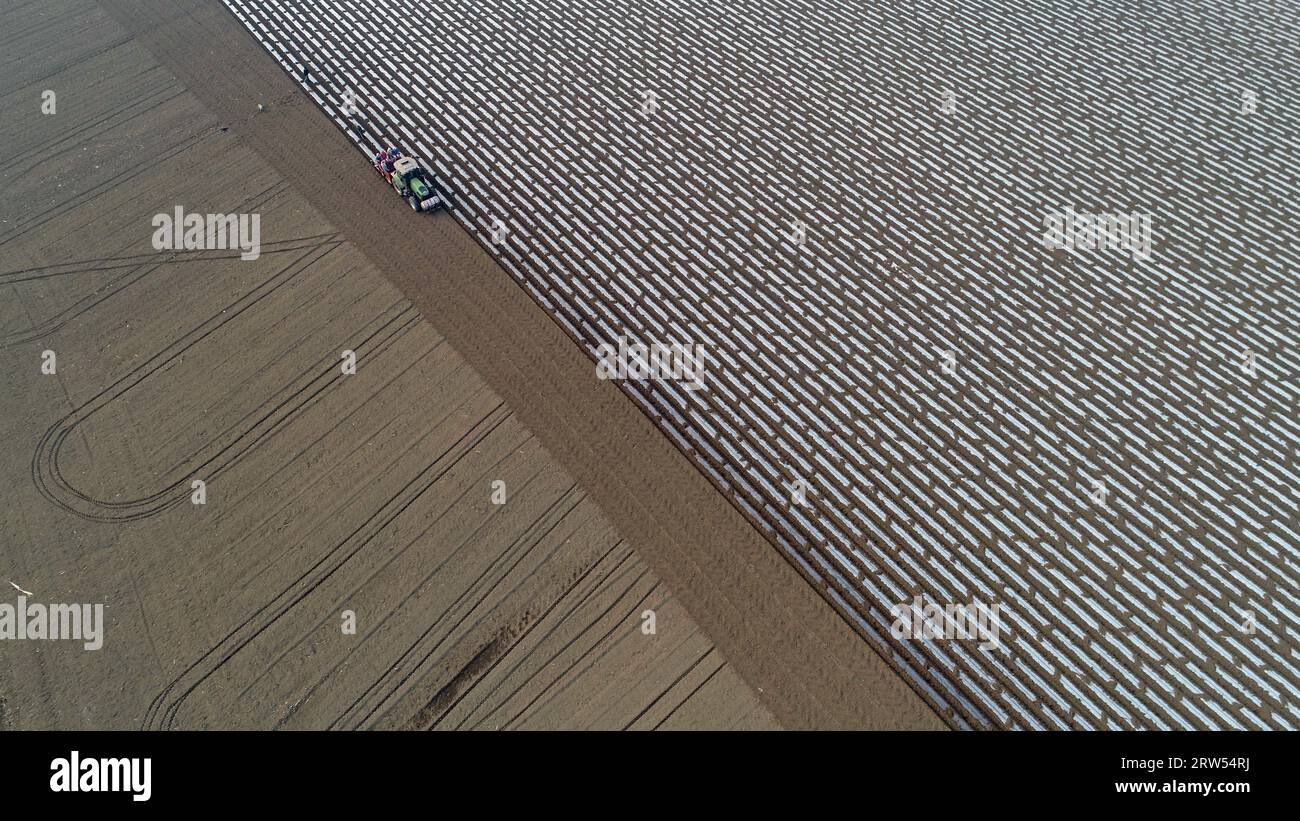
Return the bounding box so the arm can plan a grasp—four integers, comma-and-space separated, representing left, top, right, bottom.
208, 0, 1300, 729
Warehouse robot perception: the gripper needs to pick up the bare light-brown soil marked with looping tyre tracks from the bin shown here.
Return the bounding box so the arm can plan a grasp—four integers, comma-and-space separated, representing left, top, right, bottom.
0, 0, 776, 729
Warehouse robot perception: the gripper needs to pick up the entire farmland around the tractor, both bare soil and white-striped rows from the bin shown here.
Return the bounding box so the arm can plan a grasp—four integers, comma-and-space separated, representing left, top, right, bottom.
0, 0, 1300, 737
